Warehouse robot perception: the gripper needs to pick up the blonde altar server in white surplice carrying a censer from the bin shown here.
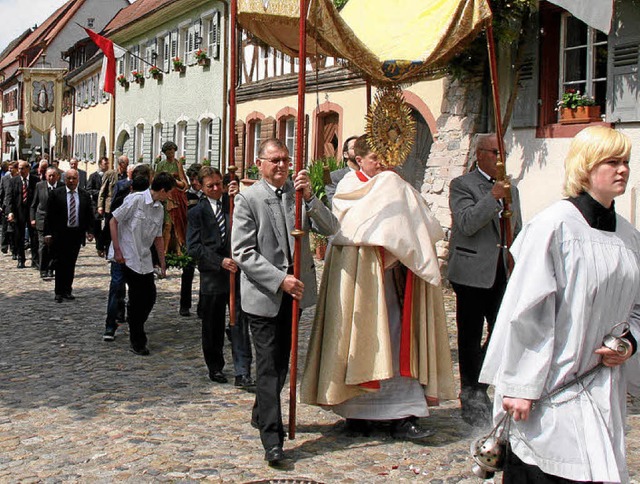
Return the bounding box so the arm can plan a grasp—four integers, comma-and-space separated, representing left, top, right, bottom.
480, 126, 640, 484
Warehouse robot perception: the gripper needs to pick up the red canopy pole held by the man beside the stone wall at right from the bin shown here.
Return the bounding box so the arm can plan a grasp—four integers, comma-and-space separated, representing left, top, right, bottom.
487, 23, 513, 275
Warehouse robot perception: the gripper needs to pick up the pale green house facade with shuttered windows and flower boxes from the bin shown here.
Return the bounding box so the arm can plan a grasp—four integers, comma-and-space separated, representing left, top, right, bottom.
105, 0, 228, 167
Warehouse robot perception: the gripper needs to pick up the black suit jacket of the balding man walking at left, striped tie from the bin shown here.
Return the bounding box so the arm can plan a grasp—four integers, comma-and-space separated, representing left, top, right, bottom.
44, 186, 93, 244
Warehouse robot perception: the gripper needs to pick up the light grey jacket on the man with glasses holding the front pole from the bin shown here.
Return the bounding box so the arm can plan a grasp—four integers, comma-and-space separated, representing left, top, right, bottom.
231, 180, 338, 317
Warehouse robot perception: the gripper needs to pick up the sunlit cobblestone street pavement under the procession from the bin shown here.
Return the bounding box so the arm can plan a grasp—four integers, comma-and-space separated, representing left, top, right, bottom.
0, 246, 640, 483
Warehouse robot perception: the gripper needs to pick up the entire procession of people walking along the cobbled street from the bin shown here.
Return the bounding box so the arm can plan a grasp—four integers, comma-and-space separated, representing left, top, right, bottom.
0, 126, 640, 483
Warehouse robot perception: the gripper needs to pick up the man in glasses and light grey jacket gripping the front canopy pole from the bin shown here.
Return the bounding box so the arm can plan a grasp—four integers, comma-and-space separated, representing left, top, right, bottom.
231, 139, 338, 465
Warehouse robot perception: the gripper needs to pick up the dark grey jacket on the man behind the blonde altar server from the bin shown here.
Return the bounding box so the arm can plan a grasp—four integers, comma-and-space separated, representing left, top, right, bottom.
448, 170, 522, 288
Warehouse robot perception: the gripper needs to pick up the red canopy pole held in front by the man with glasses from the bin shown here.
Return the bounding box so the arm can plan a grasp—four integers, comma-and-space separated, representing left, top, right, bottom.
289, 0, 308, 439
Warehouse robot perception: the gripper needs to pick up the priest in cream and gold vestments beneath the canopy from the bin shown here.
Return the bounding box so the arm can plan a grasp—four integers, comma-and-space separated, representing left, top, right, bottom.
301, 136, 455, 440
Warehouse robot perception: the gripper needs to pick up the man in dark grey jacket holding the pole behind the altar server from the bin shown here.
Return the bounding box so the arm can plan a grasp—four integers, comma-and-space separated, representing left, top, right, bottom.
448, 134, 522, 426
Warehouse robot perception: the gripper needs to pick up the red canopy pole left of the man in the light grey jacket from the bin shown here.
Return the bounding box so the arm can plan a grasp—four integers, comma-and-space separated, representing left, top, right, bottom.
227, 0, 238, 326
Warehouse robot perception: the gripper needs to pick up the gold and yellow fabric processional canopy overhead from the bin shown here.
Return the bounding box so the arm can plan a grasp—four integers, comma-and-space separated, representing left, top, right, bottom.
238, 0, 491, 85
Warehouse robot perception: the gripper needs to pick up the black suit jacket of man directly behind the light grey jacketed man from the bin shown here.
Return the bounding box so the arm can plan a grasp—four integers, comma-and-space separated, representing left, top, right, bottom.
187, 197, 231, 294
